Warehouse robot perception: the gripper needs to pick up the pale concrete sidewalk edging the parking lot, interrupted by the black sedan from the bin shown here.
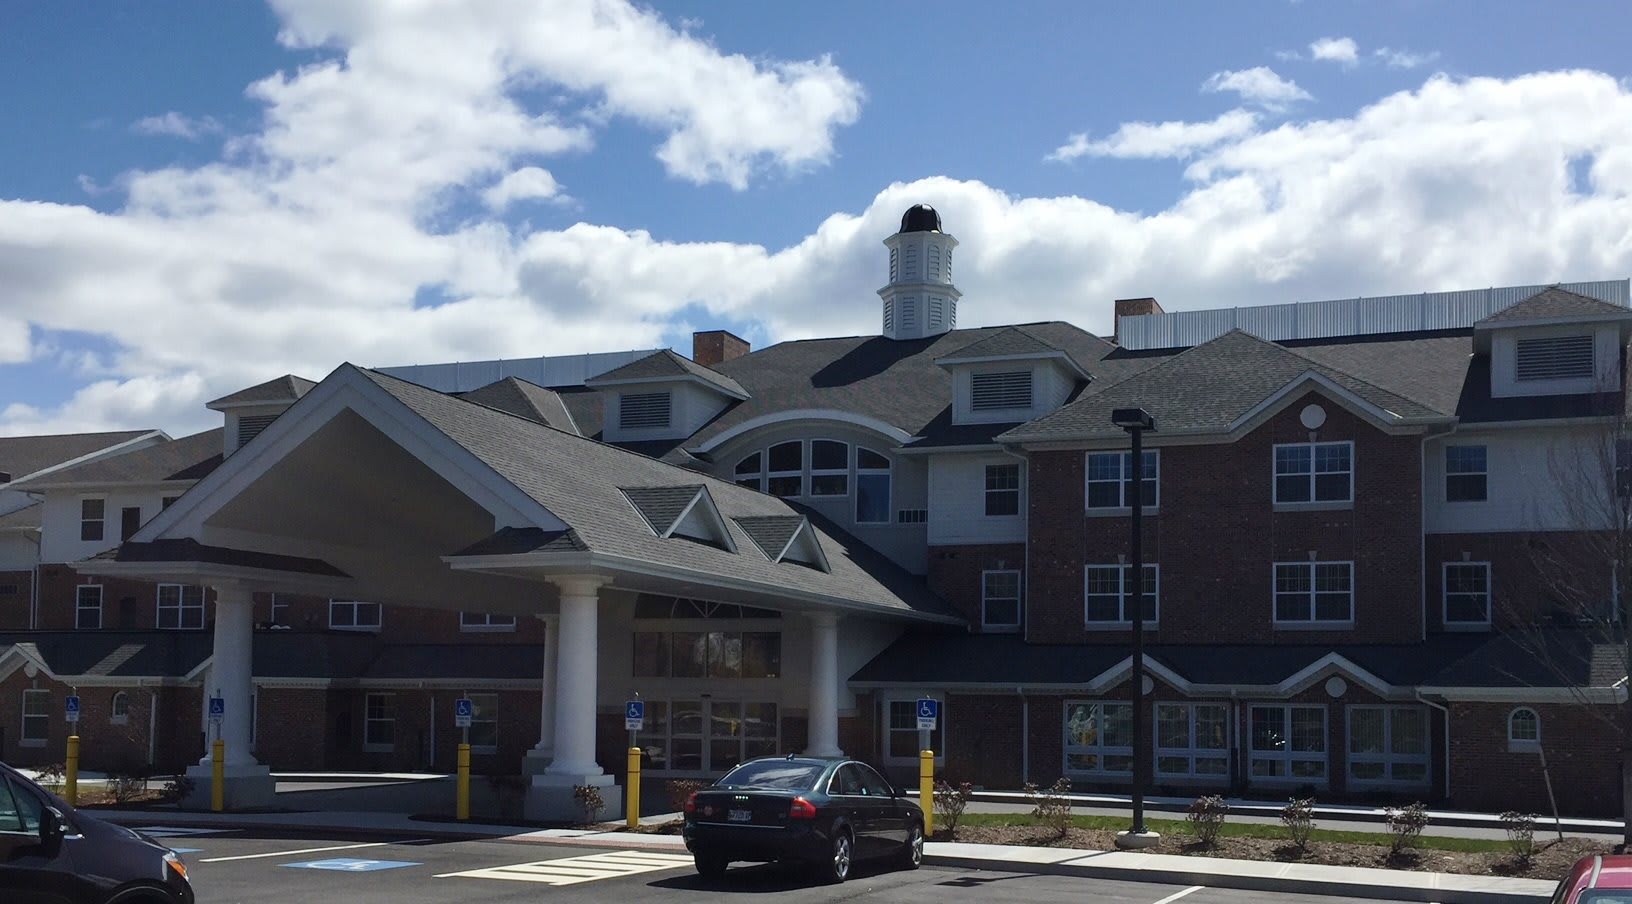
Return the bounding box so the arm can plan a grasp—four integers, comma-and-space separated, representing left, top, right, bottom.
96, 811, 1554, 904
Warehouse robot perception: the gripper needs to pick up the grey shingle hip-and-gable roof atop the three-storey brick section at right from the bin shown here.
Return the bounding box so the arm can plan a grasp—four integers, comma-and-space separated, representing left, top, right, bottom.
999, 330, 1444, 441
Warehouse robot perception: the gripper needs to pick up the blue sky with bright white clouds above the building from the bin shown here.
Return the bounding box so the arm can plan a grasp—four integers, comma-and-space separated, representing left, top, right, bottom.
0, 0, 1632, 436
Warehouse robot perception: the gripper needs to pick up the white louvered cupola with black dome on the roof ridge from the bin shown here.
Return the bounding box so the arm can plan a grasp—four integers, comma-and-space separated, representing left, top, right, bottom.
878, 204, 961, 339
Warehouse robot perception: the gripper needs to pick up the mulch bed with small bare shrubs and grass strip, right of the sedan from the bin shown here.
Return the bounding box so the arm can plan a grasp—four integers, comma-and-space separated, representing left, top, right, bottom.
934, 826, 1612, 881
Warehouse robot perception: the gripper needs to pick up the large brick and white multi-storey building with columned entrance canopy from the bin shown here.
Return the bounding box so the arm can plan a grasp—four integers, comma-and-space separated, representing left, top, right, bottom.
0, 206, 1632, 816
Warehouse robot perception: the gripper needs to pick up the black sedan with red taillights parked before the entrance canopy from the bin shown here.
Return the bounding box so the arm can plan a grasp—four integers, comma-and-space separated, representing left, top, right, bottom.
685, 756, 924, 883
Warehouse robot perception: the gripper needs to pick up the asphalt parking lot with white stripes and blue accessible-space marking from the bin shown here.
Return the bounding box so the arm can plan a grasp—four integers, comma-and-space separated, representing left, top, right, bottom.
155, 824, 1455, 904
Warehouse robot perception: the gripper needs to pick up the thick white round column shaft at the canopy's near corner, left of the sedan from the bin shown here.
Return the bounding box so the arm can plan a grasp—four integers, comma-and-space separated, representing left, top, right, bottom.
545, 574, 605, 777
